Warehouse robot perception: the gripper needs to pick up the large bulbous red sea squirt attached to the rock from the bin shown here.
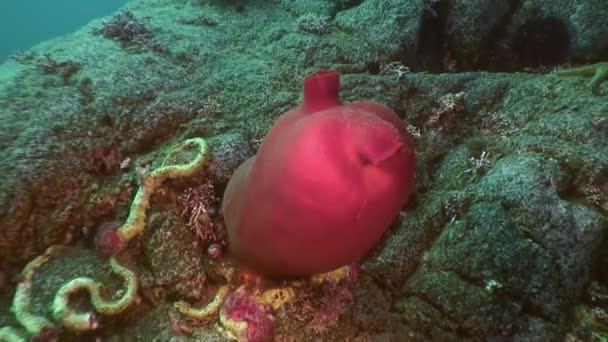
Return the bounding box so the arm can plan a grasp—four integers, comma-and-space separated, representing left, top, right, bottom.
222, 70, 415, 276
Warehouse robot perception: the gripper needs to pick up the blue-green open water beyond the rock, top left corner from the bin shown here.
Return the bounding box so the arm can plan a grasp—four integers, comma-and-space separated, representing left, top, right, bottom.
0, 0, 127, 63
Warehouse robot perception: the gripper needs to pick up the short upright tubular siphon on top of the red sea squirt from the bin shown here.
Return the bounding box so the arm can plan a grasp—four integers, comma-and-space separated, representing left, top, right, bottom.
302, 69, 340, 113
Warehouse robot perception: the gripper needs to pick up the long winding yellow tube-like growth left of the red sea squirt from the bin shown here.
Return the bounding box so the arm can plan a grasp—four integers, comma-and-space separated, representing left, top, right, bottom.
0, 138, 209, 342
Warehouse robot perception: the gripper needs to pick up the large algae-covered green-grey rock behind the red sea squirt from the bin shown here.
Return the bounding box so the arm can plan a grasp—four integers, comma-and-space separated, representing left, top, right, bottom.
0, 0, 608, 341
